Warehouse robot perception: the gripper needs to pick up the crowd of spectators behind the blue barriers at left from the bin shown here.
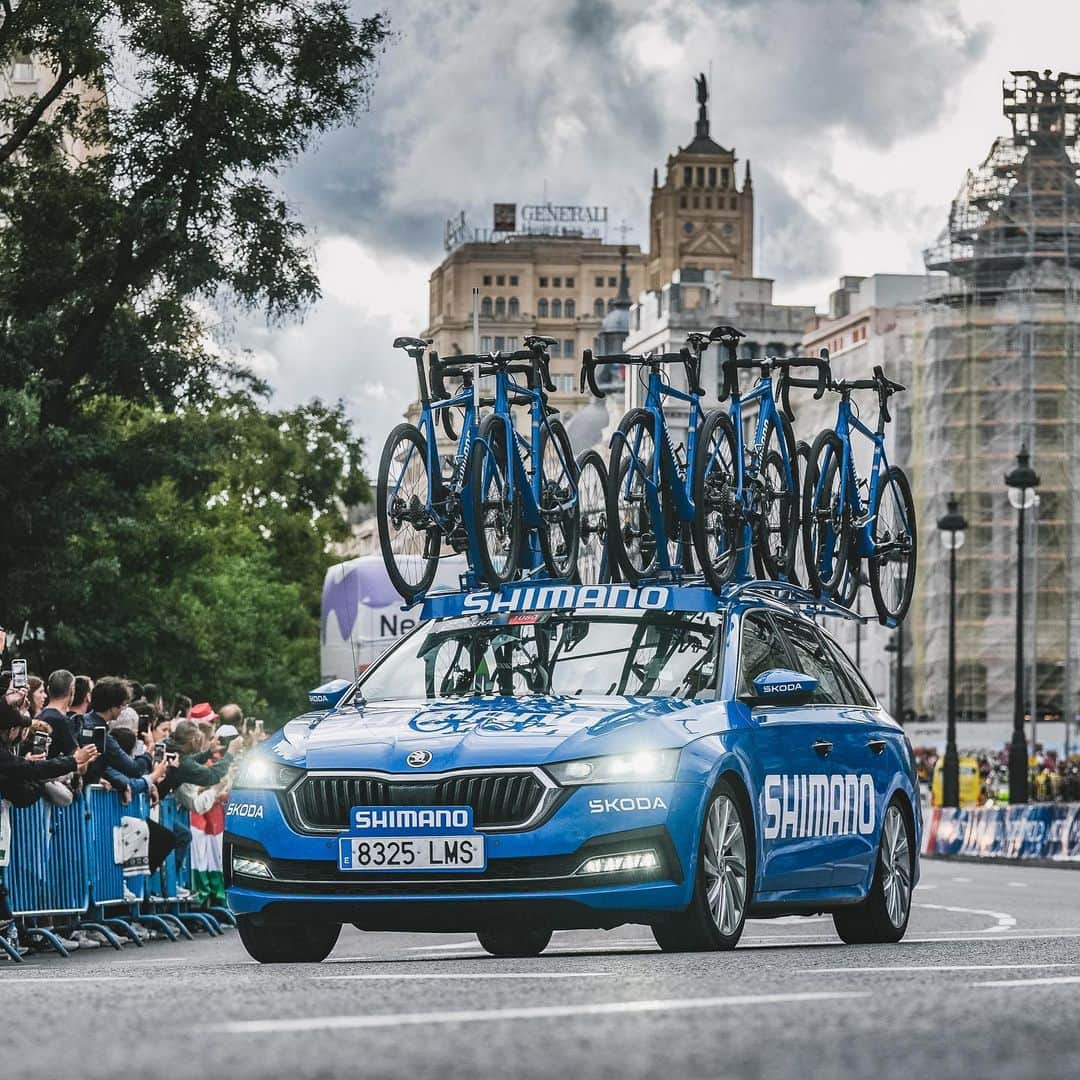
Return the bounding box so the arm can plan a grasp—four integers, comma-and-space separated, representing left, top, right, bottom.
0, 629, 265, 951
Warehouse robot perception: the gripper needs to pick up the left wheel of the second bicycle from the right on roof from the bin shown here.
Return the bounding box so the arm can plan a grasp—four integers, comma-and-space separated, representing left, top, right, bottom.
691, 409, 742, 589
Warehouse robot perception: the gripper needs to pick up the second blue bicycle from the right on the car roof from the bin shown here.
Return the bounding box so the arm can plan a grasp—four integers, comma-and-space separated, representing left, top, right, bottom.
693, 326, 828, 589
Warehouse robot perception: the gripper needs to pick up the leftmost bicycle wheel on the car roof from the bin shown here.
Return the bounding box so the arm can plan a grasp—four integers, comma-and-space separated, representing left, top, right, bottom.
375, 423, 442, 603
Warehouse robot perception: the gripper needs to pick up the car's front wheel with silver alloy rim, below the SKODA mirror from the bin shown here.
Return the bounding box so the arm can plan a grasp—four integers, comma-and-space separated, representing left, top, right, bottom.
652, 779, 754, 953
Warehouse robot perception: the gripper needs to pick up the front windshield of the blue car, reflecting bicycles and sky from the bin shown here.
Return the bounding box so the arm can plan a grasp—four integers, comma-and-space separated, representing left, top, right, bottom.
360, 611, 719, 701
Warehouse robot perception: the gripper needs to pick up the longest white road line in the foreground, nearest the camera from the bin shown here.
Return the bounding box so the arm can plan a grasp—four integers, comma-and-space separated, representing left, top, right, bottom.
211, 990, 869, 1035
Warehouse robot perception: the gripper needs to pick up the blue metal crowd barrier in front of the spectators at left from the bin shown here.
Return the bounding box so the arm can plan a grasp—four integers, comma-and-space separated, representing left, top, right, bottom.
0, 786, 225, 960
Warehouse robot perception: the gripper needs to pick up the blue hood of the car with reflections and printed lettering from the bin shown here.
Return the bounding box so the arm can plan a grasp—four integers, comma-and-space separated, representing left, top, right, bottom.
271, 697, 727, 773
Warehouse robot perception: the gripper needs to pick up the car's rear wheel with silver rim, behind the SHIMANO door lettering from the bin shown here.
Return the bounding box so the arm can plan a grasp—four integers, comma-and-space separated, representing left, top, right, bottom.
833, 798, 915, 945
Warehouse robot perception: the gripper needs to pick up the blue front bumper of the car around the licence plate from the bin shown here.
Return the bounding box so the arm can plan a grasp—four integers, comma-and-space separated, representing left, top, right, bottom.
225, 782, 704, 930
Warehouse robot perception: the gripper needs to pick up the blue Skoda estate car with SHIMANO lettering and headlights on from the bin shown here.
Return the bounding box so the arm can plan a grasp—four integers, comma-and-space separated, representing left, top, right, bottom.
225, 583, 921, 962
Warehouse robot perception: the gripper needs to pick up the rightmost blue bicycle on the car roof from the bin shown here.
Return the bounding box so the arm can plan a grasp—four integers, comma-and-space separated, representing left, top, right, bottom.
802, 366, 918, 625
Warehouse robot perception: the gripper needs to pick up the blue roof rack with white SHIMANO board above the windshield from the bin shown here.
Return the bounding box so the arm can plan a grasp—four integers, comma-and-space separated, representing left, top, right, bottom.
412, 578, 869, 623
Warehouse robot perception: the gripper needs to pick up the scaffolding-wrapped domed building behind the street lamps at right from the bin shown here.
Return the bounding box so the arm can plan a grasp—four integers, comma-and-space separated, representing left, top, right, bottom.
896, 71, 1080, 748
